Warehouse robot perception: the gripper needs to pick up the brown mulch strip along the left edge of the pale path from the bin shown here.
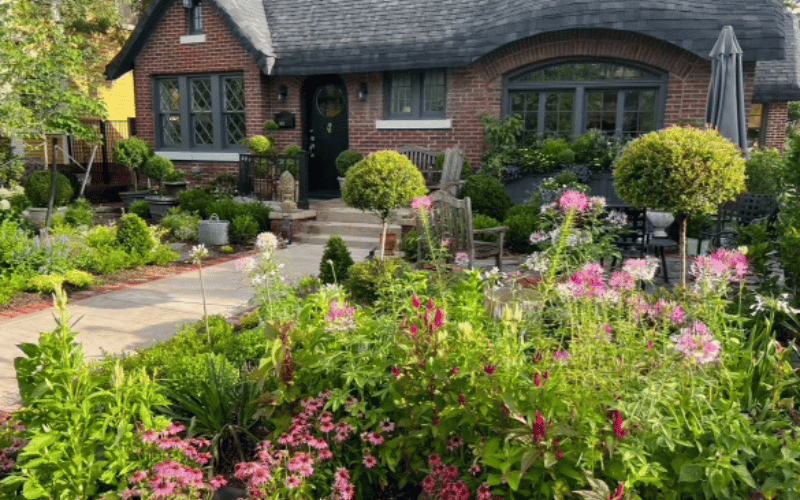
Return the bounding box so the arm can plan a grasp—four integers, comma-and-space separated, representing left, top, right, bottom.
0, 246, 253, 321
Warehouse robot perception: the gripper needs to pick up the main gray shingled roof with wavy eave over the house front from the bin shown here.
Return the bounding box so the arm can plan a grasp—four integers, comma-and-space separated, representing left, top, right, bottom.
106, 0, 786, 88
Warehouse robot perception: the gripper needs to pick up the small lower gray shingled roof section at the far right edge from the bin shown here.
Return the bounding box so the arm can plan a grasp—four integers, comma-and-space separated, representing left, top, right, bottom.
753, 14, 800, 103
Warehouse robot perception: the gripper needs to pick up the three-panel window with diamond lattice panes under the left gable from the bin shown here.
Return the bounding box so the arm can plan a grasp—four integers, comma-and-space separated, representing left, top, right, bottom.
153, 75, 247, 150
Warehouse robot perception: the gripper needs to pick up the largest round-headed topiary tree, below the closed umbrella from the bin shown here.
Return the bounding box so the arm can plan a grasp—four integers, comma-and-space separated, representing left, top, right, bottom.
614, 126, 745, 286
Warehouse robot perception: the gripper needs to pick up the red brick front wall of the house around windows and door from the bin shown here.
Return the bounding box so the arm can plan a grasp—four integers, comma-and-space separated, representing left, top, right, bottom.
135, 7, 756, 182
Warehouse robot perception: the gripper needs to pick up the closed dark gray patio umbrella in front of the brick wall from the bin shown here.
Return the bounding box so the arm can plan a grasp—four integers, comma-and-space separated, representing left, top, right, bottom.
706, 26, 747, 155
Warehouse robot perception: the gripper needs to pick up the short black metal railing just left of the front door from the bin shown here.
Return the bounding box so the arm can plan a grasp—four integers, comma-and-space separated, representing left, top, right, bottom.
239, 151, 308, 208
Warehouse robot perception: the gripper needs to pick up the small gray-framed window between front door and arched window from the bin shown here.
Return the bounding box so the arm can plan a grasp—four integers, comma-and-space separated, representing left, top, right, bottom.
386, 69, 447, 120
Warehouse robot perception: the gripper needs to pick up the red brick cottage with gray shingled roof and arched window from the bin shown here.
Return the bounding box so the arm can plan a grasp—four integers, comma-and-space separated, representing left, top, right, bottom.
105, 0, 800, 192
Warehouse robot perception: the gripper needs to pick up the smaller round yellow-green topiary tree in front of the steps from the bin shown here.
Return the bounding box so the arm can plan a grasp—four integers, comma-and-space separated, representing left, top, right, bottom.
342, 151, 427, 260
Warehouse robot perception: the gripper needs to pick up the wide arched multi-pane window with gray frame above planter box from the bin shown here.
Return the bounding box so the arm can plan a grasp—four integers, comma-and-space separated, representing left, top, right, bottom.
503, 60, 667, 137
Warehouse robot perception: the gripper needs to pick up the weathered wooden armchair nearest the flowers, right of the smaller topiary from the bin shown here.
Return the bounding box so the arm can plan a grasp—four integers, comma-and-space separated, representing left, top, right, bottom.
417, 190, 508, 270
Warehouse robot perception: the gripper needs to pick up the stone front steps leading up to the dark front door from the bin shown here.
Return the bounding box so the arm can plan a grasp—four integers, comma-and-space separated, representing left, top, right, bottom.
293, 199, 410, 250
